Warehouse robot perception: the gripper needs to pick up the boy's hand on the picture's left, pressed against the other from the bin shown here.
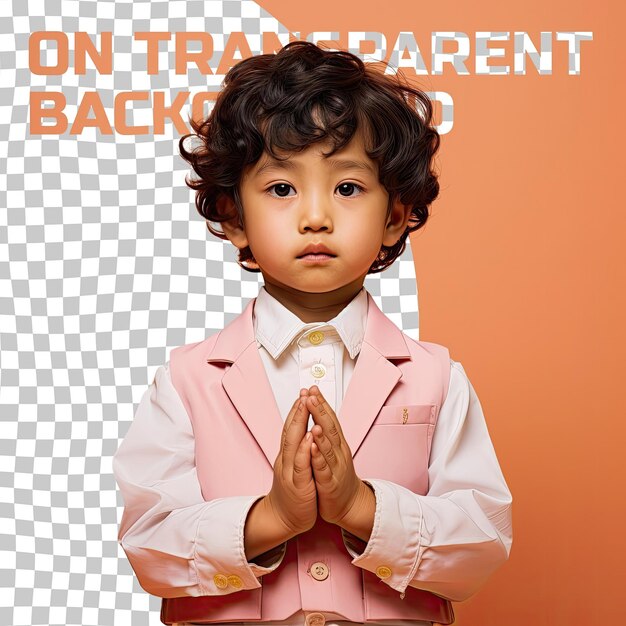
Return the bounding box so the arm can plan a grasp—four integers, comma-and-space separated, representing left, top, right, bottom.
267, 390, 317, 536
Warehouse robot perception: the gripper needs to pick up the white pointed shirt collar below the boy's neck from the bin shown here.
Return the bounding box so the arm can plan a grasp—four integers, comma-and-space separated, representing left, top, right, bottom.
252, 286, 367, 359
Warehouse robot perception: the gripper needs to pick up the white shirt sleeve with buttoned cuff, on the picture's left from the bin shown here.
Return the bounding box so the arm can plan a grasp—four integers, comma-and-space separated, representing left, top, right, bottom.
112, 362, 284, 598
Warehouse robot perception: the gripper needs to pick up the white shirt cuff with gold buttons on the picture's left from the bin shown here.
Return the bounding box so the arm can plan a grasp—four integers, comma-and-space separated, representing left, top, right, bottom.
193, 496, 286, 595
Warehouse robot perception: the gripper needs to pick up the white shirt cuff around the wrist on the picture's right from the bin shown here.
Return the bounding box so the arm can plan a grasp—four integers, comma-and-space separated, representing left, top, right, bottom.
343, 479, 423, 593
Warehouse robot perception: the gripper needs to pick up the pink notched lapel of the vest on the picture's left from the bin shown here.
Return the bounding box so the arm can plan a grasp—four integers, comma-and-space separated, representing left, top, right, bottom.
207, 299, 283, 467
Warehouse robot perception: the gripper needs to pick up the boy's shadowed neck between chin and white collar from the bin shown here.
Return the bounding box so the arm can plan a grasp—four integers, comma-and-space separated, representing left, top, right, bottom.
264, 278, 363, 324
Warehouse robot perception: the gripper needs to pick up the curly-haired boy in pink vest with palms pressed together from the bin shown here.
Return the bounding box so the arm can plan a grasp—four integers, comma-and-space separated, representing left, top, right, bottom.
113, 41, 511, 626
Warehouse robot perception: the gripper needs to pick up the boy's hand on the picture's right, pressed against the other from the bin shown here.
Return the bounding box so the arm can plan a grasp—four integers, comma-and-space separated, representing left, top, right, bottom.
307, 385, 373, 527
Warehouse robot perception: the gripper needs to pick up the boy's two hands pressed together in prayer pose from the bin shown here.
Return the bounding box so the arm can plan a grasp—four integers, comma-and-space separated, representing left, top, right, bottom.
244, 385, 376, 562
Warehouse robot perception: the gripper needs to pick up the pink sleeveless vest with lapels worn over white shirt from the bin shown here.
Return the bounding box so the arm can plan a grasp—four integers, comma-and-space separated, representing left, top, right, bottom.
161, 293, 454, 624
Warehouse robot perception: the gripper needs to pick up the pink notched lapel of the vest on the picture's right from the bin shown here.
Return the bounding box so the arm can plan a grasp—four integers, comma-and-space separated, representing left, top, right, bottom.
339, 292, 411, 456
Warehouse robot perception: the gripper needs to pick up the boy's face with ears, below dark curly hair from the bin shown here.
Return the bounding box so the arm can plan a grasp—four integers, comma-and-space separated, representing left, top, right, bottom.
219, 133, 410, 312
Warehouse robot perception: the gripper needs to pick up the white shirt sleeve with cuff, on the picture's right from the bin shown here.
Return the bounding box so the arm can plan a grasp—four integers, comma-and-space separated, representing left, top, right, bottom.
344, 360, 512, 601
